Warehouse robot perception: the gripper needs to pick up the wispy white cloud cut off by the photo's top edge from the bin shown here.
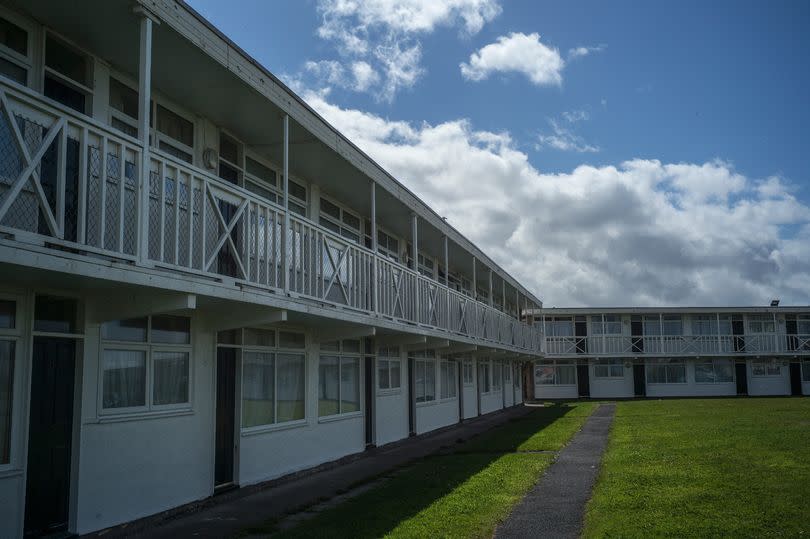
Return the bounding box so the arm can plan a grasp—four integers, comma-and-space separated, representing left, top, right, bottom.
310, 0, 501, 103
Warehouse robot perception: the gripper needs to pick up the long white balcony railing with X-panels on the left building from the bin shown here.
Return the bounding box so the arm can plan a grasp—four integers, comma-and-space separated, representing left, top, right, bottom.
0, 82, 545, 353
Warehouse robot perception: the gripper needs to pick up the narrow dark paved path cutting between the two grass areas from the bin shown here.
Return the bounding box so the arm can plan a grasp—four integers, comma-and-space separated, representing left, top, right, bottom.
495, 404, 616, 539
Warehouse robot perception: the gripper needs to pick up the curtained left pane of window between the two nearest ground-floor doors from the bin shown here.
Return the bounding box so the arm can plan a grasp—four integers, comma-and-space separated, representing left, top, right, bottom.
102, 350, 146, 408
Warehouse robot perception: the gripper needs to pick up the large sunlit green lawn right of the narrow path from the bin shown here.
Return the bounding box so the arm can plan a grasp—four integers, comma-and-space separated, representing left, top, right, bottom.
584, 398, 810, 537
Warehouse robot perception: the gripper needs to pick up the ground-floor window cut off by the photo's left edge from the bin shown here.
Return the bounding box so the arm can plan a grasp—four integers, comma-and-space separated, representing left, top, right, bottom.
0, 298, 19, 466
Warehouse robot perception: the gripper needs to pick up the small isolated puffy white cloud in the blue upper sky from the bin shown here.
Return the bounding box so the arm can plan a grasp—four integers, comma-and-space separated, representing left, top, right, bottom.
459, 32, 565, 86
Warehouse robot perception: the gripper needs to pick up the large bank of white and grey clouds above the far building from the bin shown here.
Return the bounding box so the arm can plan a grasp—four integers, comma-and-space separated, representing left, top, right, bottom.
306, 94, 810, 306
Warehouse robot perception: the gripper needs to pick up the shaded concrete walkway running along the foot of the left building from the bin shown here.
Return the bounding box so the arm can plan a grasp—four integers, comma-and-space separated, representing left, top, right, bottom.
86, 406, 532, 539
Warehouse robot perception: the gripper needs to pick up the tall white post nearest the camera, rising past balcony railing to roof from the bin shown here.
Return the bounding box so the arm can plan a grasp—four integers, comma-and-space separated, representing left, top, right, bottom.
133, 6, 155, 264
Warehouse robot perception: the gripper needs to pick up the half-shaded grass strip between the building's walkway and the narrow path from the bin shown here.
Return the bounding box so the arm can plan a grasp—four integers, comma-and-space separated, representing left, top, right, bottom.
247, 404, 594, 539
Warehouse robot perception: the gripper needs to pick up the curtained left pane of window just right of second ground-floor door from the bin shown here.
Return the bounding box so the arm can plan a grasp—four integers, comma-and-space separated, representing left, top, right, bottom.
242, 352, 276, 427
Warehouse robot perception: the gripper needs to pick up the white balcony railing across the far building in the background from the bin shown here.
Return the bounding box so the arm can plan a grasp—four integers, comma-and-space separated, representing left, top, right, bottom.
546, 333, 810, 356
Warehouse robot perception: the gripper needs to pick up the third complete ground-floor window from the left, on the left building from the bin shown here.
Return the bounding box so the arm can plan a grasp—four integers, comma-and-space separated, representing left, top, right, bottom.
318, 340, 360, 417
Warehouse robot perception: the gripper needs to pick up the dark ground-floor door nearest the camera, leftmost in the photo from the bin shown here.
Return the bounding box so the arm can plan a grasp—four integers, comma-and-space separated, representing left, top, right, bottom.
25, 337, 76, 535
